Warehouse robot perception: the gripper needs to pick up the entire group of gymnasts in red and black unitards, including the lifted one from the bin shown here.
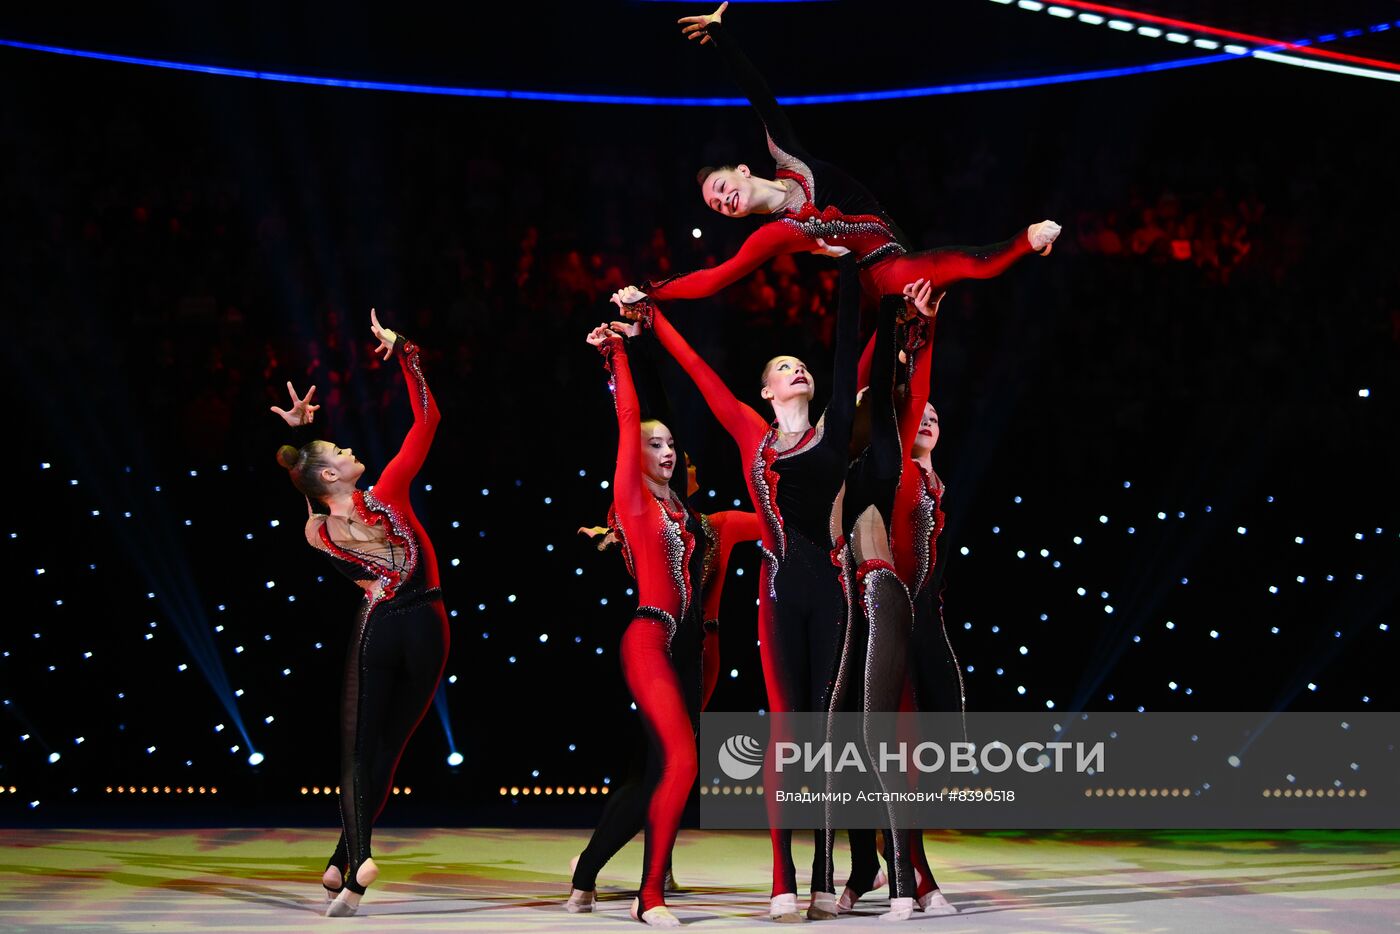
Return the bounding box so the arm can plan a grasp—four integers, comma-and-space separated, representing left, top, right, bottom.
273, 4, 1060, 927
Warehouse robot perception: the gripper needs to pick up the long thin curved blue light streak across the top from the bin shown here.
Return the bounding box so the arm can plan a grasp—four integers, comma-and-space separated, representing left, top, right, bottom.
0, 39, 1239, 106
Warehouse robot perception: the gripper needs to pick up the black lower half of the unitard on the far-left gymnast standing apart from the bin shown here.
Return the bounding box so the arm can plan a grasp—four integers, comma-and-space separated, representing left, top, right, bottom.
326, 591, 448, 895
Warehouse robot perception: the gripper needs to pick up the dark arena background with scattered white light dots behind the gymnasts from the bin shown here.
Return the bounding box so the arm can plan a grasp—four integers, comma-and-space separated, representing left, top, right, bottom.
0, 0, 1400, 823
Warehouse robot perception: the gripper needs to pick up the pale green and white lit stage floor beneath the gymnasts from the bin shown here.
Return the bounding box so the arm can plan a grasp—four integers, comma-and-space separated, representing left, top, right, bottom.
0, 829, 1400, 934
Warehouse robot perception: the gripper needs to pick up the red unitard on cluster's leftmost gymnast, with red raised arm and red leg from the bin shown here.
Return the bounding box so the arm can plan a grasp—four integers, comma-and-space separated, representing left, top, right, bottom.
590, 330, 700, 913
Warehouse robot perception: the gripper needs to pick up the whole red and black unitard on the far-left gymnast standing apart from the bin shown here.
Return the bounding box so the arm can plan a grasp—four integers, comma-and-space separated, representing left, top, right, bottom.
307, 335, 448, 893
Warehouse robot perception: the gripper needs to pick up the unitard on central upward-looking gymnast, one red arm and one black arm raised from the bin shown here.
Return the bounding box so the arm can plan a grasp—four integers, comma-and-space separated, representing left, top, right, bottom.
644, 258, 860, 896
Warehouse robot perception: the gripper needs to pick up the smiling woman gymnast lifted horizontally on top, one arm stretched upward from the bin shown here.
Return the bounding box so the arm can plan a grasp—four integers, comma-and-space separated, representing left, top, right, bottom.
616, 3, 1060, 301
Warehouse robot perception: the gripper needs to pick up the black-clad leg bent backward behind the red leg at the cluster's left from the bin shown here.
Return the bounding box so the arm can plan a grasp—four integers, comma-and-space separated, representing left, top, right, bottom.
571, 612, 703, 892
